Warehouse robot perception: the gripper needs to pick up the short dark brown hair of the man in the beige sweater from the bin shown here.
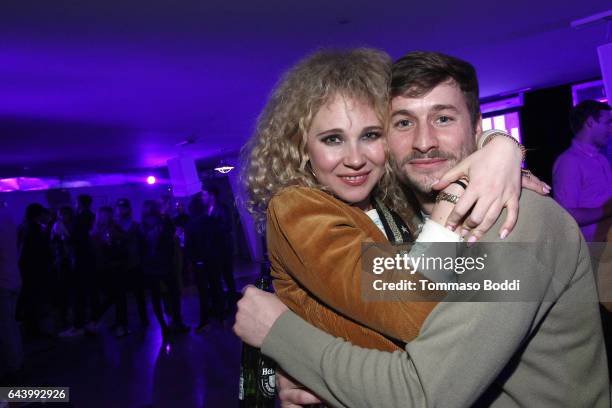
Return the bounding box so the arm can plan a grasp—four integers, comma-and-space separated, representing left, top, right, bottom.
391, 51, 480, 128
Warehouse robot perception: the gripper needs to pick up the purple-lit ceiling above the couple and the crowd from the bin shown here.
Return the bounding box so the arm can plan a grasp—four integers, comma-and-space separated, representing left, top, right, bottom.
0, 0, 610, 178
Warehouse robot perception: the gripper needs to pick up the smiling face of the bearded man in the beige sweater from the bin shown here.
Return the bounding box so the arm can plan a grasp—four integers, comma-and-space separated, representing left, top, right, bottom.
388, 80, 481, 194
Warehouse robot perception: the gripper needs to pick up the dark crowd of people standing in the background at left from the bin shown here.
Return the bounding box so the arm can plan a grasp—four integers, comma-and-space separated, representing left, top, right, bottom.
1, 186, 237, 384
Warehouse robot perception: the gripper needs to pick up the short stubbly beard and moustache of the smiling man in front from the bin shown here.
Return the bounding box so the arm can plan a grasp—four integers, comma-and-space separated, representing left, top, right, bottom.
391, 146, 473, 196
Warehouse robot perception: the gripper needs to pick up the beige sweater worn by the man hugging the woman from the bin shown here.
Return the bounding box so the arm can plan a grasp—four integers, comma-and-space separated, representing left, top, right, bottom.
262, 191, 610, 408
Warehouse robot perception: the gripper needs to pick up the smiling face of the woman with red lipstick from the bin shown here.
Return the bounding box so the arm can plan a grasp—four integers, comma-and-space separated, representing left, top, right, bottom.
306, 95, 385, 210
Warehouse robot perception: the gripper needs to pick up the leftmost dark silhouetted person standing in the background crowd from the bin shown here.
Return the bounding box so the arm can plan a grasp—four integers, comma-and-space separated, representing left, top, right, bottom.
17, 203, 52, 335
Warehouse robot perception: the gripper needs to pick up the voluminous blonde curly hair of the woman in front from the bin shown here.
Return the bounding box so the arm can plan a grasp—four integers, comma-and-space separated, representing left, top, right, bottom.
241, 48, 412, 228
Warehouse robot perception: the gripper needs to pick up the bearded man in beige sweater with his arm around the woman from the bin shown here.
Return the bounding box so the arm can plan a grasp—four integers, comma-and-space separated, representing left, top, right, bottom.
234, 52, 610, 408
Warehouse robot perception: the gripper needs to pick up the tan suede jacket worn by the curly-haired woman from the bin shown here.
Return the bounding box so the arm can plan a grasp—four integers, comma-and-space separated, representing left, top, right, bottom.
267, 187, 436, 351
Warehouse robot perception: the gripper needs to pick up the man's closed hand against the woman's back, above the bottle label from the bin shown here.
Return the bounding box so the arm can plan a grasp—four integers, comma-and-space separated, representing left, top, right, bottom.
234, 285, 288, 348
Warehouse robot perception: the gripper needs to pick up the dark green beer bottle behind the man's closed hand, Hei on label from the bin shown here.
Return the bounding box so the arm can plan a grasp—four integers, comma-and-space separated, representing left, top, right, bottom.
238, 261, 276, 408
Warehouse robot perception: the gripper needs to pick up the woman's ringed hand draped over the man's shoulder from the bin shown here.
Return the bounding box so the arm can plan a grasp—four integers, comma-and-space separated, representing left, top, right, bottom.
433, 137, 550, 241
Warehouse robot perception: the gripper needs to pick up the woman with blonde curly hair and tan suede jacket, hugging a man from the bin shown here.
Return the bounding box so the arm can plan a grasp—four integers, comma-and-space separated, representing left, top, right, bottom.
245, 50, 544, 350
